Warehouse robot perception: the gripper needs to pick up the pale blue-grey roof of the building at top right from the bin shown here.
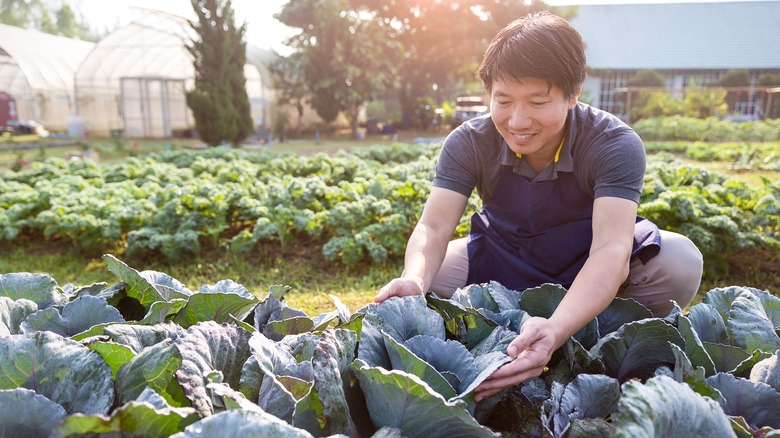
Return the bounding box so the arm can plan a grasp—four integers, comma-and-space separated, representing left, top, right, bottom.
571, 0, 780, 70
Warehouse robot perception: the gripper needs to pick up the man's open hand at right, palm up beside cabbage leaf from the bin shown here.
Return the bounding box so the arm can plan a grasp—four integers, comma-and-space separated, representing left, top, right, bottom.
474, 317, 558, 401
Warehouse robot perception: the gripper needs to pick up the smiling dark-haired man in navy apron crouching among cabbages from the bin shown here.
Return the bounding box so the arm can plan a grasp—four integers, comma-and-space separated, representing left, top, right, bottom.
374, 13, 702, 401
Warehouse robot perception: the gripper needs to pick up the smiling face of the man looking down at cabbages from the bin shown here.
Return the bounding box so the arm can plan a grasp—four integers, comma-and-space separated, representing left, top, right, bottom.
490, 78, 577, 167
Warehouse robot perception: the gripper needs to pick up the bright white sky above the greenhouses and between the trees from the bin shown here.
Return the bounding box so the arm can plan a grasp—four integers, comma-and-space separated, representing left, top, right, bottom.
71, 0, 756, 55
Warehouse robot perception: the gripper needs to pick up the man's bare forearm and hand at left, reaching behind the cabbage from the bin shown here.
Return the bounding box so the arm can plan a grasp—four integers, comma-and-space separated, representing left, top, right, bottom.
374, 187, 468, 303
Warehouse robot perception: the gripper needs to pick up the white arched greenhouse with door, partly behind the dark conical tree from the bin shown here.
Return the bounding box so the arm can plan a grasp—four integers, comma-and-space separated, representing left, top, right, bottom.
75, 8, 267, 138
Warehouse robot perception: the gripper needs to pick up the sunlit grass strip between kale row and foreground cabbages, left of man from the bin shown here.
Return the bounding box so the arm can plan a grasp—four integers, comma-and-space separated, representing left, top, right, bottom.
0, 237, 402, 316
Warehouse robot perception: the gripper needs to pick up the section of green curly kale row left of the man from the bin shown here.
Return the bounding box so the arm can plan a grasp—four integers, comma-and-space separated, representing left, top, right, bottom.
0, 145, 470, 264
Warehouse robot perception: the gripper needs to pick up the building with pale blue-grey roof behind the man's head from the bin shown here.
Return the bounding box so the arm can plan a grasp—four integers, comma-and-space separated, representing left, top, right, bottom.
570, 0, 780, 120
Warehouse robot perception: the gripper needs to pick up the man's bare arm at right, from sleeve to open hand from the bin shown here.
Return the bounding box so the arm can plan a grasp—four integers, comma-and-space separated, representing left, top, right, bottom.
475, 197, 637, 401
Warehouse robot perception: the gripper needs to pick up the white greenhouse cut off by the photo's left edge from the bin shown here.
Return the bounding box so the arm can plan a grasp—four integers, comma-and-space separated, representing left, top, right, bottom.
0, 24, 95, 132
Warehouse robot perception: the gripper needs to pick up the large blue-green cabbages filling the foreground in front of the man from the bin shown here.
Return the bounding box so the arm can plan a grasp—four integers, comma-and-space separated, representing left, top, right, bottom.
0, 256, 780, 438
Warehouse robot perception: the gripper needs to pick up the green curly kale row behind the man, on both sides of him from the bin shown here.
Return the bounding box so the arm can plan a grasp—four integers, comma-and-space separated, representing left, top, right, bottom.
0, 145, 780, 270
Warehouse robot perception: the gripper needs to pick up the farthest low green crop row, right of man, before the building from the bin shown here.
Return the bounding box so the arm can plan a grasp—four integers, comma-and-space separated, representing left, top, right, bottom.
632, 116, 780, 142
